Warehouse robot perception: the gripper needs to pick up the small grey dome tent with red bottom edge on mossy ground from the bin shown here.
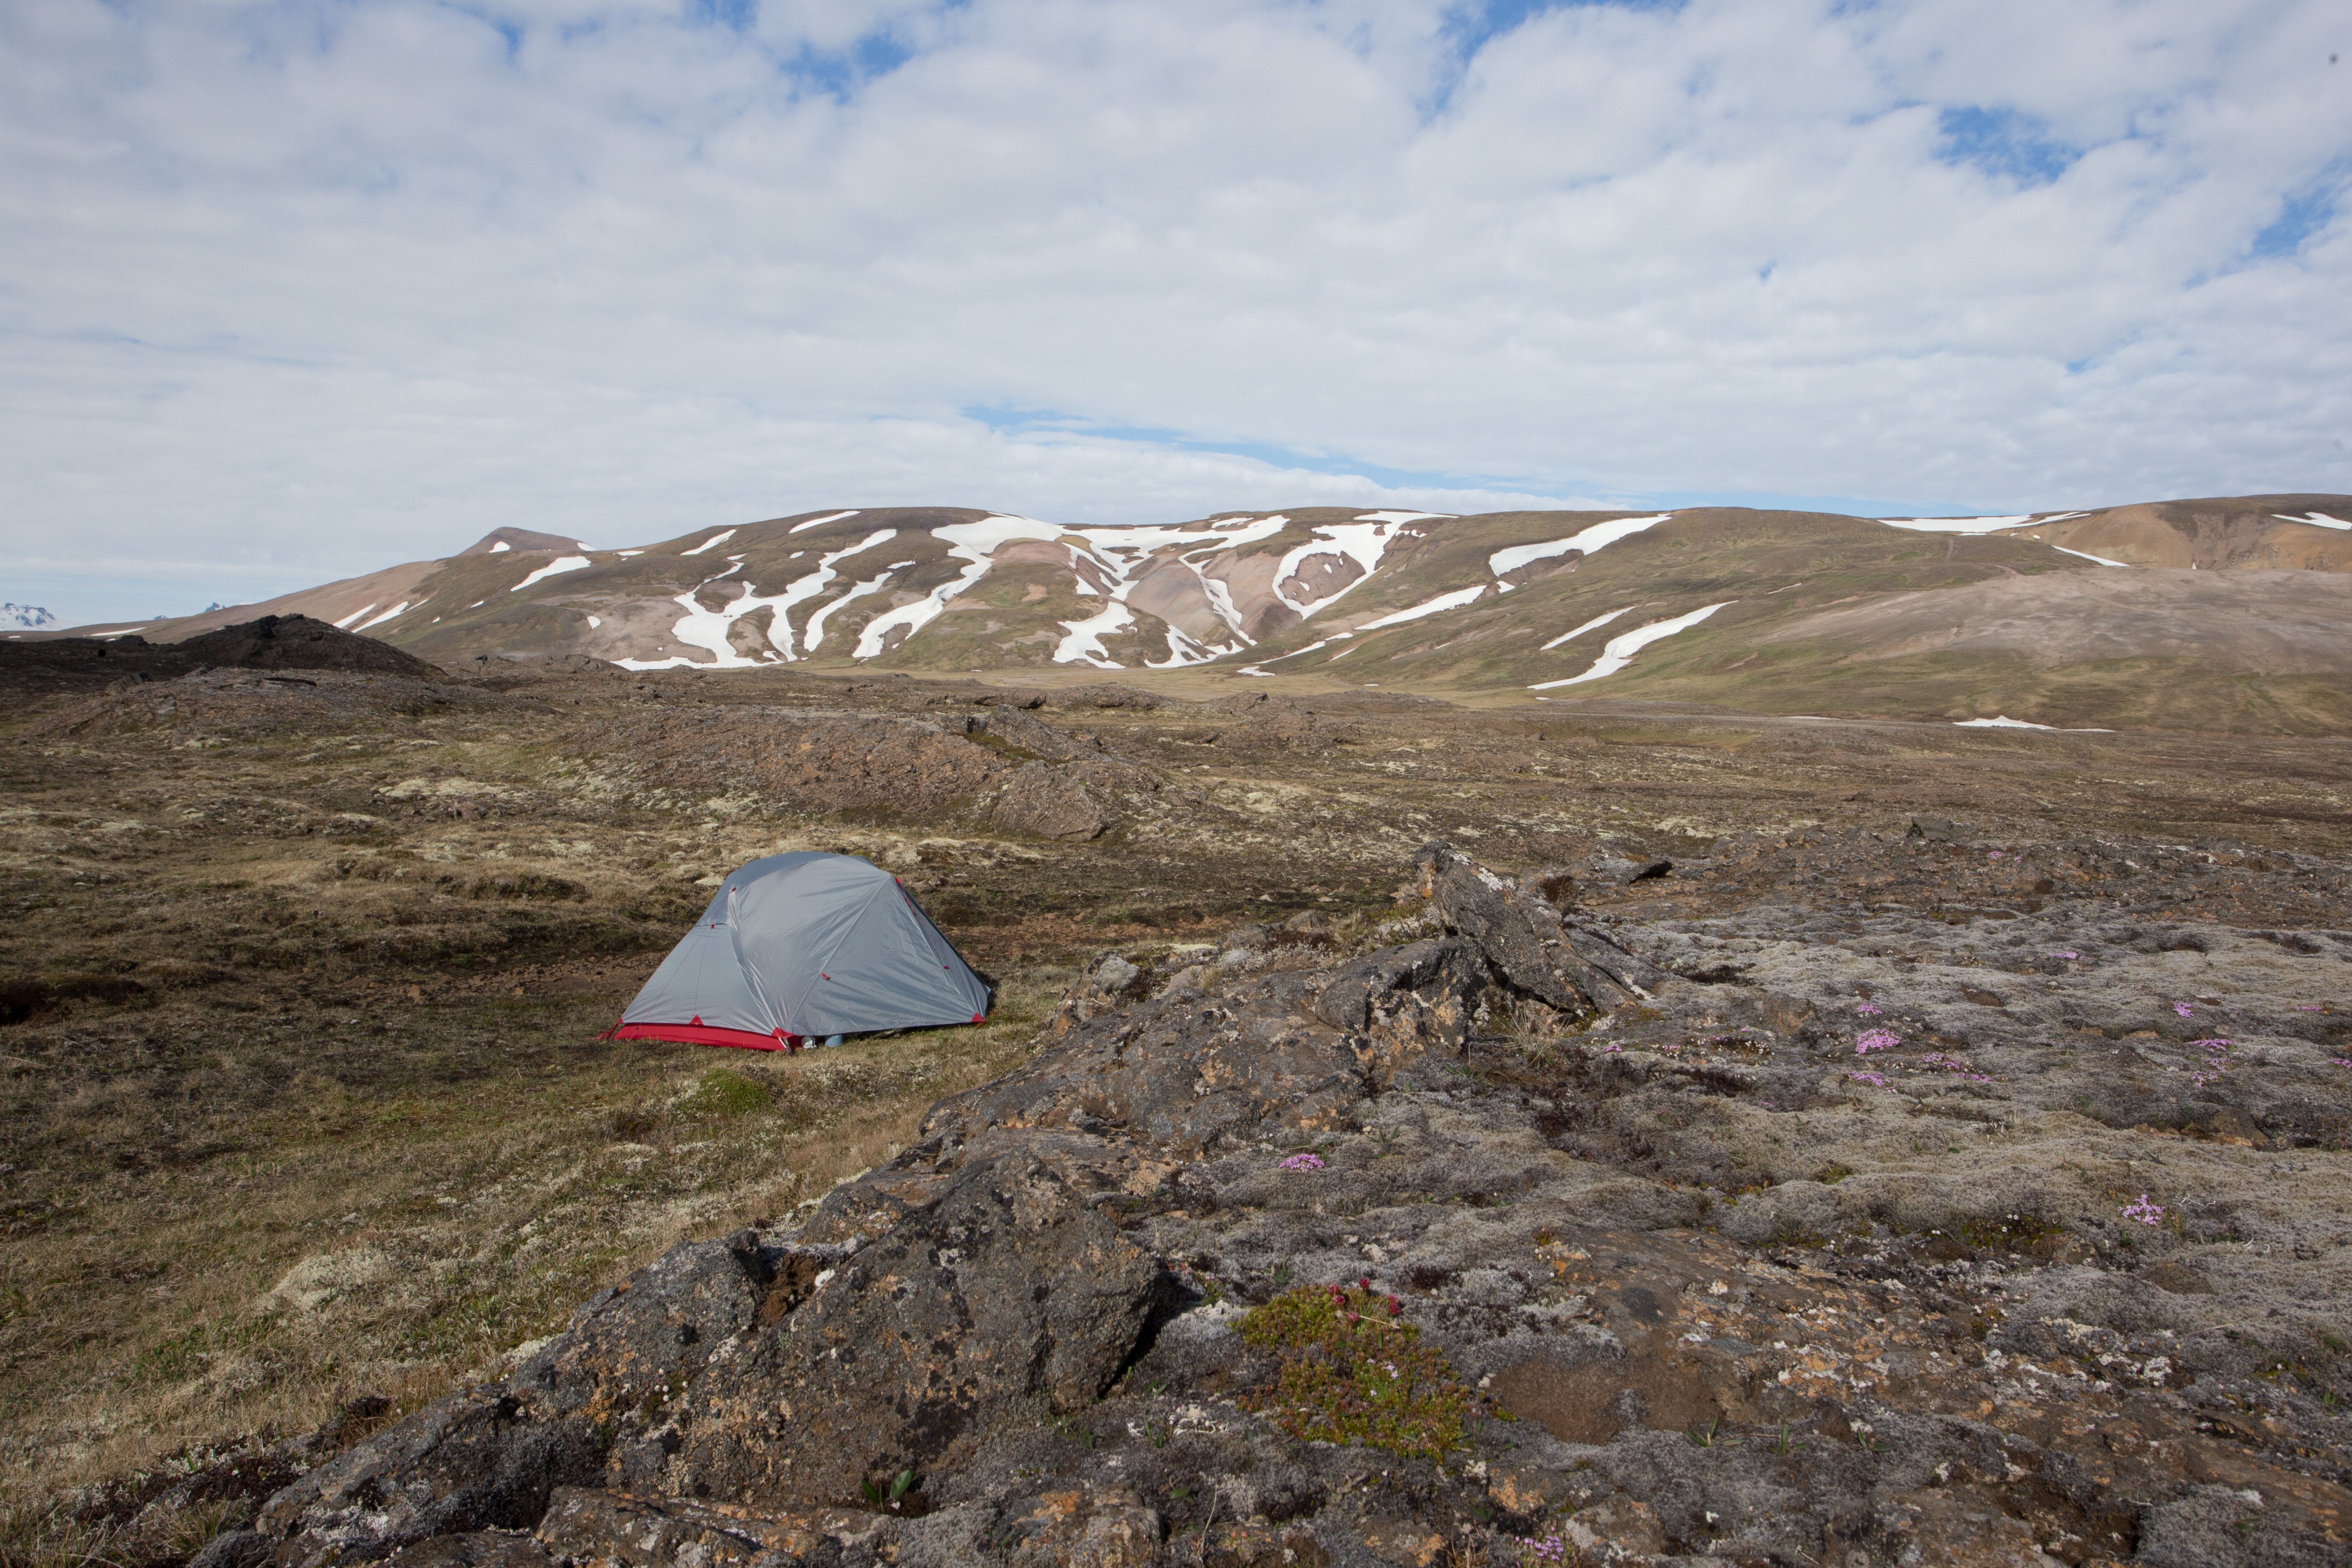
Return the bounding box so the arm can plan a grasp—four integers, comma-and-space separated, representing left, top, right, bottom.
612, 851, 988, 1051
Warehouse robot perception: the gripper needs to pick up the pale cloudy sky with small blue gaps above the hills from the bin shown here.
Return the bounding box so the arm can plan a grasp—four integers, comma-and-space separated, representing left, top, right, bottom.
0, 0, 2352, 621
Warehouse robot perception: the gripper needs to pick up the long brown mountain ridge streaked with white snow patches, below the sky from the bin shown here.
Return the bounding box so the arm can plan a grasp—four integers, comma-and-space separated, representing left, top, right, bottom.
32, 494, 2352, 726
